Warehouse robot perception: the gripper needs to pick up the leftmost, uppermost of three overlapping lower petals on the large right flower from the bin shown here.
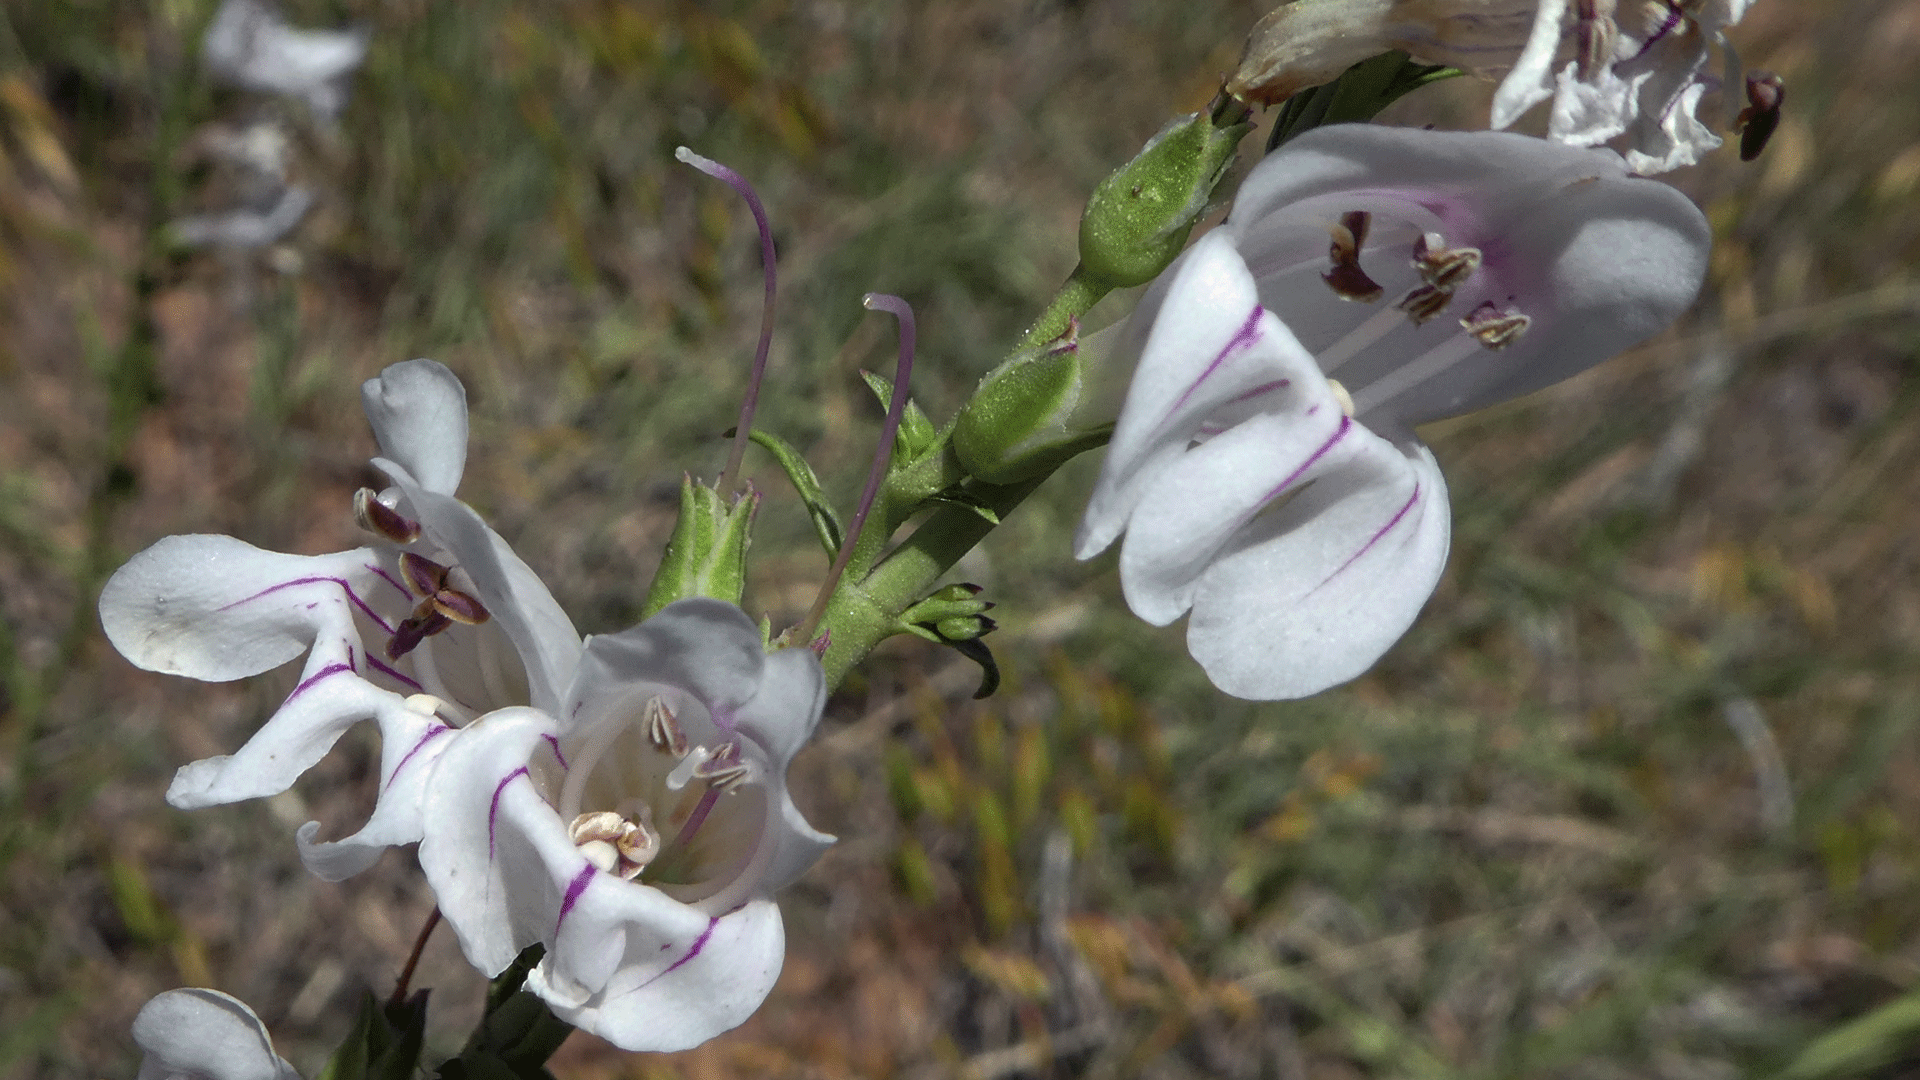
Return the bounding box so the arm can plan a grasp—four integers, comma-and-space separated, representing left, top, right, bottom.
1073, 229, 1331, 559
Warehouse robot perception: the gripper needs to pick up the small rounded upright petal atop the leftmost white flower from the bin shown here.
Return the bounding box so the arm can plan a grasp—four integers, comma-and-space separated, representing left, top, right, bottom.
361, 359, 467, 496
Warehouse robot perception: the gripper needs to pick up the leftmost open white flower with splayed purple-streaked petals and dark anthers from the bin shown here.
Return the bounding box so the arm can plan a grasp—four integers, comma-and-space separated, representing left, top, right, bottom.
100, 359, 580, 880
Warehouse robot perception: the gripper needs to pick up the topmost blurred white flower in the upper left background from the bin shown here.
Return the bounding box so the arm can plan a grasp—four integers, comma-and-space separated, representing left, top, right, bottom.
200, 0, 369, 119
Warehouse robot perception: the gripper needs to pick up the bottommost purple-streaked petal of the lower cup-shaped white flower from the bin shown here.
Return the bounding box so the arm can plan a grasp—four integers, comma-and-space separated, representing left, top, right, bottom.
528, 899, 785, 1051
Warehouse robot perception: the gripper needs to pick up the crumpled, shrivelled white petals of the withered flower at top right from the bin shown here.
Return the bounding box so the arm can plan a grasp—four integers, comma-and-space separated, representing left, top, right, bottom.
1492, 0, 1749, 175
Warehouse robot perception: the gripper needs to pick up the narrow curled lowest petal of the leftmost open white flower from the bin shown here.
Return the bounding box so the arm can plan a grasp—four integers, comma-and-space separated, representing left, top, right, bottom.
296, 691, 453, 882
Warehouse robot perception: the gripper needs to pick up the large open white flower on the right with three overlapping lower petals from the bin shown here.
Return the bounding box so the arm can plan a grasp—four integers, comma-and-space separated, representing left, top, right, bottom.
1075, 125, 1709, 698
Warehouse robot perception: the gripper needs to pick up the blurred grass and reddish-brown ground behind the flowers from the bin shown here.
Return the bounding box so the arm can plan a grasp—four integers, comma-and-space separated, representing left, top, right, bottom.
0, 0, 1920, 1080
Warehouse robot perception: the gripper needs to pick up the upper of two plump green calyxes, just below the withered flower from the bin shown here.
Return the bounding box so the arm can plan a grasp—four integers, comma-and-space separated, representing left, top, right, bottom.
1079, 111, 1254, 288
